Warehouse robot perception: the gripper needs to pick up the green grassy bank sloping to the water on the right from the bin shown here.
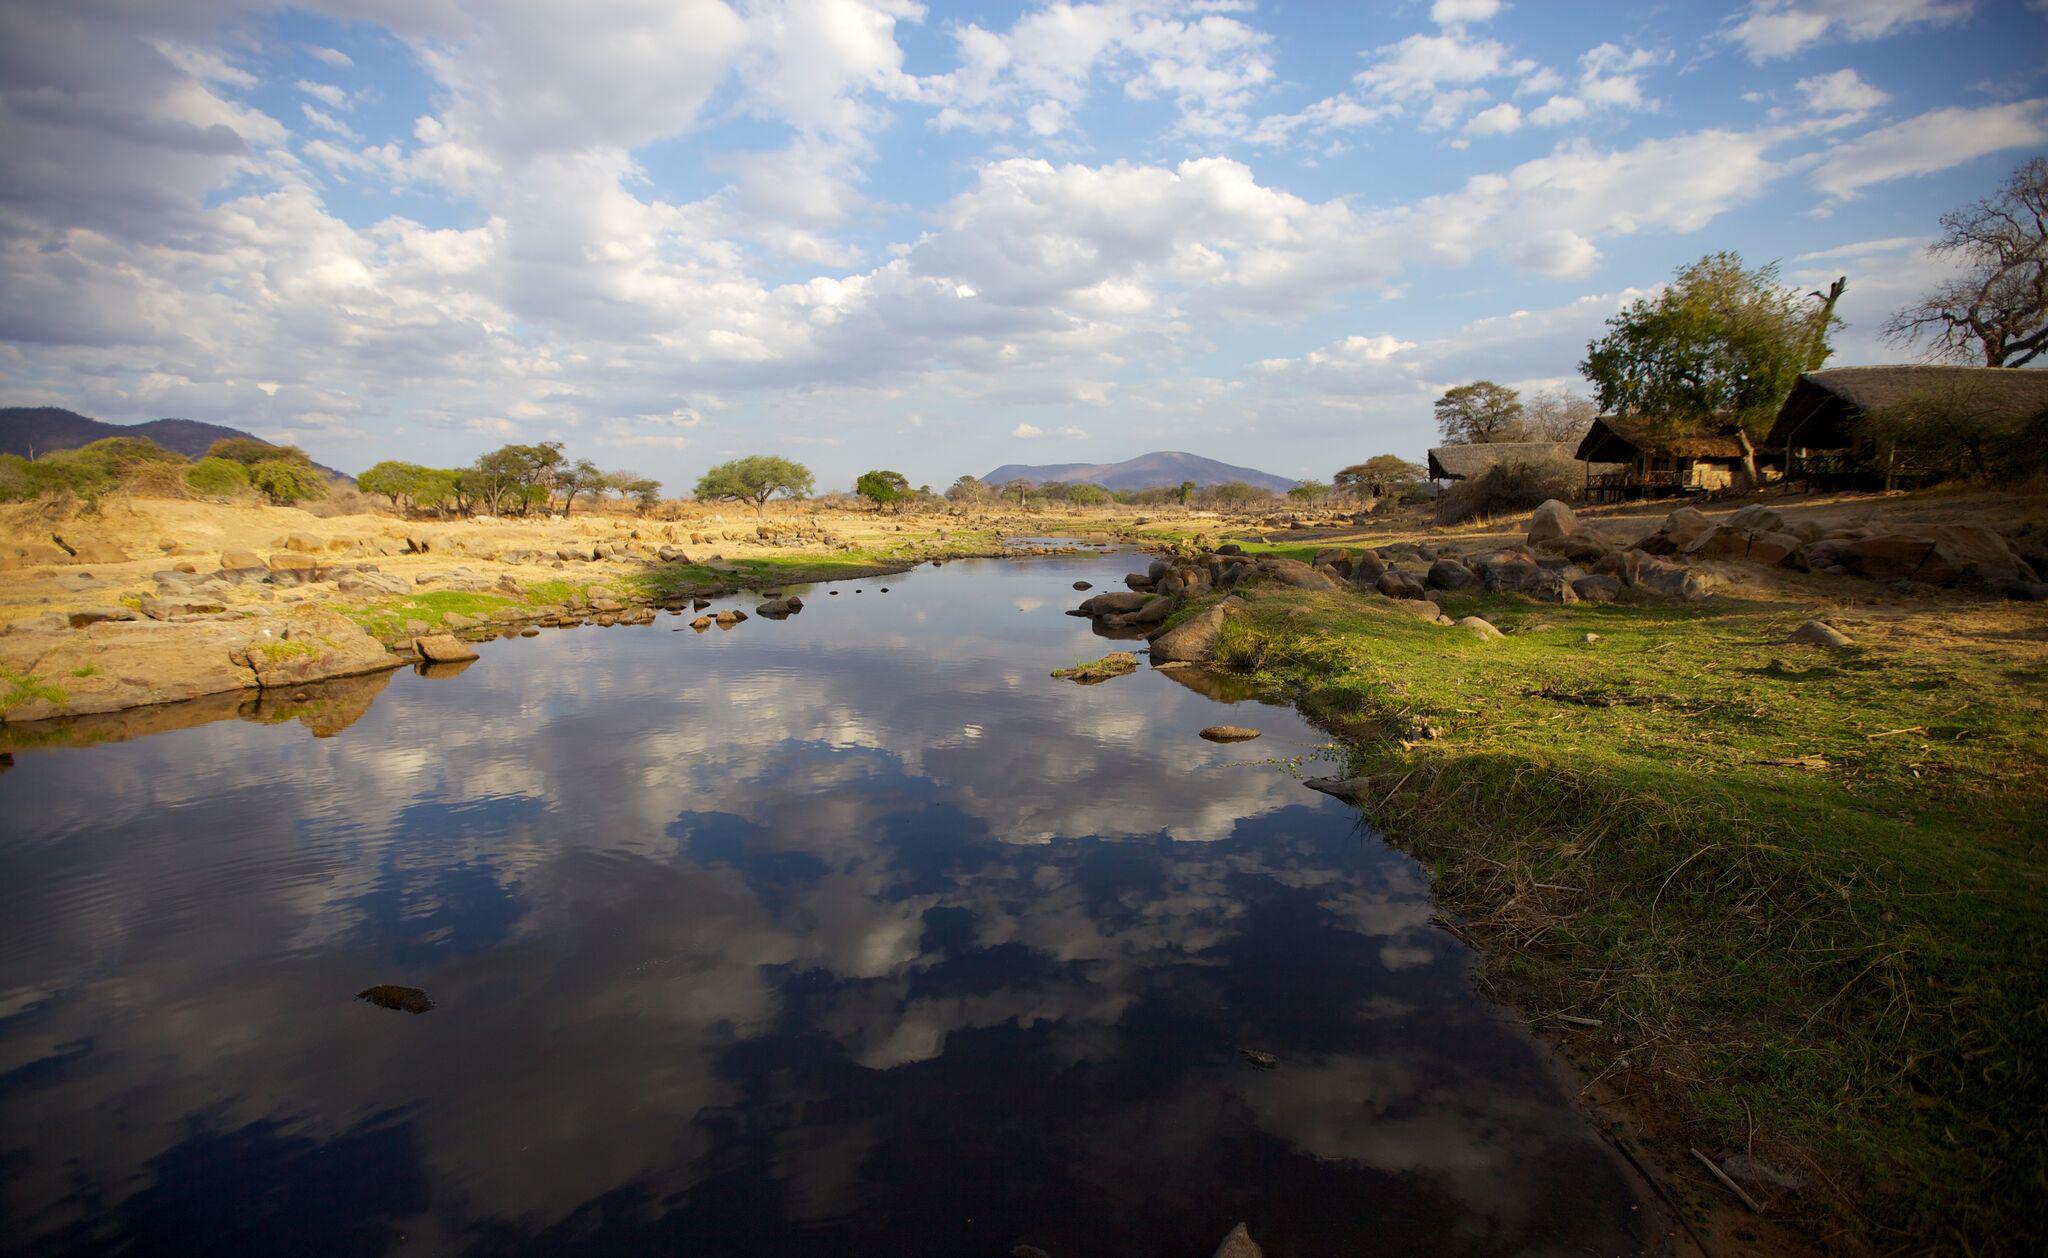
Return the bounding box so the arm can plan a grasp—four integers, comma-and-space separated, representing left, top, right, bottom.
1221, 590, 2048, 1252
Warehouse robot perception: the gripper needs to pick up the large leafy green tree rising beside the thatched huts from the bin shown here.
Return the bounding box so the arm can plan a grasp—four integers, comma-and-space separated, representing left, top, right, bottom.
1579, 252, 1835, 448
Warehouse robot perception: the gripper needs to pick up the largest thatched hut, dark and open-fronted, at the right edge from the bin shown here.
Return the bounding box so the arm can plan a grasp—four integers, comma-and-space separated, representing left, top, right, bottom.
1765, 365, 2048, 488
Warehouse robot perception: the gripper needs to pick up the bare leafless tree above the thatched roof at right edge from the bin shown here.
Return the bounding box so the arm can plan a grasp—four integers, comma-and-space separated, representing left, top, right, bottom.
1884, 158, 2048, 367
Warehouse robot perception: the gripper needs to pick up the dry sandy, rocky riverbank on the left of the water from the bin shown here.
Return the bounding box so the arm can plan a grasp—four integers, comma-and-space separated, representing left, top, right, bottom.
0, 500, 1146, 725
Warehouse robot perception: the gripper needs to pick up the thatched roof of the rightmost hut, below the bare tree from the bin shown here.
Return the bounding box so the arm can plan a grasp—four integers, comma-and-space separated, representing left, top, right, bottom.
1765, 365, 2048, 451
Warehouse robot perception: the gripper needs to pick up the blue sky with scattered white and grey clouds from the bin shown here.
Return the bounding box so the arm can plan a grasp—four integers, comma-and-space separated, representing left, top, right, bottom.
0, 0, 2048, 490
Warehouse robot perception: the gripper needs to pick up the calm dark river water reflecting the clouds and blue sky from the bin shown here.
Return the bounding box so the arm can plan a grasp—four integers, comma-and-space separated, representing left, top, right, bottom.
0, 557, 1642, 1258
